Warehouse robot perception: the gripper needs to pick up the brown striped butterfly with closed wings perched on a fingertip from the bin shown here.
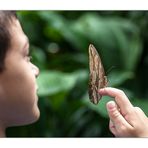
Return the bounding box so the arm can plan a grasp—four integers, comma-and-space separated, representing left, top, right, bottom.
88, 44, 108, 104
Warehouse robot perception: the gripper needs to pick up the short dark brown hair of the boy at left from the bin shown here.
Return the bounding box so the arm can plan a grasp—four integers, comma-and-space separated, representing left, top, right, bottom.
0, 11, 17, 72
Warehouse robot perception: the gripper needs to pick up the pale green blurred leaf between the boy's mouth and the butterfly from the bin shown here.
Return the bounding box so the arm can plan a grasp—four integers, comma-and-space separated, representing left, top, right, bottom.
37, 70, 87, 96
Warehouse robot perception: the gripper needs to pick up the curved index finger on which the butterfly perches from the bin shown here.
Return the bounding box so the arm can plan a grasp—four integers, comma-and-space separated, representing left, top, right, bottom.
99, 87, 133, 116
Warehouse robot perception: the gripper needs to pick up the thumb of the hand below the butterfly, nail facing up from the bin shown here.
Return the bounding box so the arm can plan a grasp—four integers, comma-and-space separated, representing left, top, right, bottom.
106, 101, 130, 130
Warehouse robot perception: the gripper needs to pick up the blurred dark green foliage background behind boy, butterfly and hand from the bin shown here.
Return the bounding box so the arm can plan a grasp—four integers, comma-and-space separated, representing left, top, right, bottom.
7, 11, 148, 137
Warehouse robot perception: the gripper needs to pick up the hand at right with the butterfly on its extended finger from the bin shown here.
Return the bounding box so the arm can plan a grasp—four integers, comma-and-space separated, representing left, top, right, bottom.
99, 87, 148, 137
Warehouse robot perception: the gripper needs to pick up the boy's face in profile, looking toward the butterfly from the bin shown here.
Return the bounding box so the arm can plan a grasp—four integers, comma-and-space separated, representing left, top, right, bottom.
0, 19, 40, 127
